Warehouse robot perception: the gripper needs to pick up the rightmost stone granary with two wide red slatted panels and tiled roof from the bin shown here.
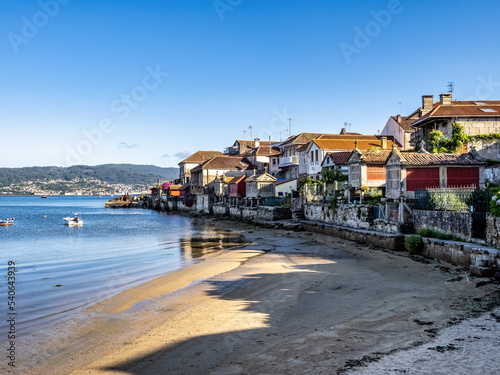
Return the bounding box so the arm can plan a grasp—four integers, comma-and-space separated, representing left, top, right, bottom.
385, 148, 486, 199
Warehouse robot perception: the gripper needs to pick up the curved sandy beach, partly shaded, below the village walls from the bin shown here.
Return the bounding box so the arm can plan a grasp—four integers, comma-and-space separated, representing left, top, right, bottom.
11, 221, 500, 375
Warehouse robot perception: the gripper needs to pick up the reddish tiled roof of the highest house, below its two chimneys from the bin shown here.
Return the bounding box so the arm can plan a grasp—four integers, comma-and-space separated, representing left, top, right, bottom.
412, 100, 500, 126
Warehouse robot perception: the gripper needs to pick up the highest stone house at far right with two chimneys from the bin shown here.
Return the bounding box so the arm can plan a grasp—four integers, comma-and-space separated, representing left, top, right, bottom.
410, 93, 500, 160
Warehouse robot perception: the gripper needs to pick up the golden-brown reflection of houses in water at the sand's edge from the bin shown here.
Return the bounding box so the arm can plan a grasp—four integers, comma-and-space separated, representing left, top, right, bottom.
180, 231, 244, 260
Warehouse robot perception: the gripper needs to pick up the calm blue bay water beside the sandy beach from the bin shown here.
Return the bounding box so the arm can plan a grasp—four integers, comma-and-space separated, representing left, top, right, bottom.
0, 196, 242, 333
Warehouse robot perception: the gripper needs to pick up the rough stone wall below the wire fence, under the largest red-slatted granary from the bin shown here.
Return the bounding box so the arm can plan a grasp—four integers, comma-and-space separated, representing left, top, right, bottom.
413, 210, 472, 241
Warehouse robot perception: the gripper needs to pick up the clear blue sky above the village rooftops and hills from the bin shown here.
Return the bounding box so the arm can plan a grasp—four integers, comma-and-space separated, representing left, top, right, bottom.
0, 0, 500, 167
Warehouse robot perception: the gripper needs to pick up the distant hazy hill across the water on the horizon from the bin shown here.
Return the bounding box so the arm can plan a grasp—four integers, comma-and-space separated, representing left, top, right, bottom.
0, 164, 179, 187
